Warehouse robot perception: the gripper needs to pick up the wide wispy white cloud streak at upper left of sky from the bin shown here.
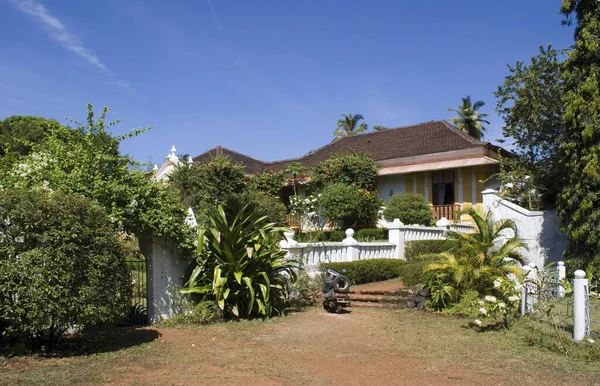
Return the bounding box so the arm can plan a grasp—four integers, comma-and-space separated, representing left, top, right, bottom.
9, 0, 139, 95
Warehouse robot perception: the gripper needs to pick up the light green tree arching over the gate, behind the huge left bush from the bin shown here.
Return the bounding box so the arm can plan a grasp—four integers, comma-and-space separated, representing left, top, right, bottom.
0, 104, 193, 251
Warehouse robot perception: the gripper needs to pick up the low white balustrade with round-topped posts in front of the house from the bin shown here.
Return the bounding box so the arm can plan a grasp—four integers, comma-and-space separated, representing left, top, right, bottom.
280, 220, 473, 268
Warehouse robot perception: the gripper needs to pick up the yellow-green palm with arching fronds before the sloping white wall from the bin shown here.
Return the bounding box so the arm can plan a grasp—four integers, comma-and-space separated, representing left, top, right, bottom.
425, 207, 527, 298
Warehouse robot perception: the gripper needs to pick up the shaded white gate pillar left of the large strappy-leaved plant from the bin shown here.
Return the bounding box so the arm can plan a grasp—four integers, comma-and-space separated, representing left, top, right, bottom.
140, 236, 190, 323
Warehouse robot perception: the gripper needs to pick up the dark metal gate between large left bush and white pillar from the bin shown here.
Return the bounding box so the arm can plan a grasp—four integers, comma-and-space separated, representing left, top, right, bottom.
122, 252, 148, 325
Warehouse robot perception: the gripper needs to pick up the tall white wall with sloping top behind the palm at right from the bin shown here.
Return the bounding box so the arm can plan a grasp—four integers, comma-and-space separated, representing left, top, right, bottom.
482, 189, 567, 269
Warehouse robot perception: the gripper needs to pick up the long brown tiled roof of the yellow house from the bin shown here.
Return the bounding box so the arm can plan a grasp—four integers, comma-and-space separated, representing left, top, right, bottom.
194, 120, 491, 174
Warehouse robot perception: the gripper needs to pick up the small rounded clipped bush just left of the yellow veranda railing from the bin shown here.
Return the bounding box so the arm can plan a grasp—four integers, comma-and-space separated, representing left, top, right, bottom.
383, 193, 434, 226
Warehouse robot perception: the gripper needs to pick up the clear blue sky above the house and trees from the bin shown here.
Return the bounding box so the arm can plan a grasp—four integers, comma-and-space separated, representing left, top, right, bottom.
0, 0, 572, 164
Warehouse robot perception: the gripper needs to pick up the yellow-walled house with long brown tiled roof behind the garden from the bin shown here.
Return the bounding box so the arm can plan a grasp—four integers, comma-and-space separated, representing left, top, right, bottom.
156, 120, 507, 221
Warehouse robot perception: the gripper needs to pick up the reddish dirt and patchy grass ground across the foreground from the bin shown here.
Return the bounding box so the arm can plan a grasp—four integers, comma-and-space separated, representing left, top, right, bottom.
0, 308, 600, 385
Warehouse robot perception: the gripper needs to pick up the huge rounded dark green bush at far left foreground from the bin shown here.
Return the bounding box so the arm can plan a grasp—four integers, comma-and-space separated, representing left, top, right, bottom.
0, 190, 131, 347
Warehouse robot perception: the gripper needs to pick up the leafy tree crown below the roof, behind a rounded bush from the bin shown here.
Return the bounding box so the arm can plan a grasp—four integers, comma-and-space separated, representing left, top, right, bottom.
311, 153, 378, 191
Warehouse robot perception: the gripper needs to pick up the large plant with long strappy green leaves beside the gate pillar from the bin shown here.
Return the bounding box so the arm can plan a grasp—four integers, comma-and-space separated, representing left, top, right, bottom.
180, 203, 298, 318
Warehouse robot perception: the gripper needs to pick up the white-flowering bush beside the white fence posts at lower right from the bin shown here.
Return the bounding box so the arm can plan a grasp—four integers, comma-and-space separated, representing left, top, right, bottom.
473, 277, 521, 328
